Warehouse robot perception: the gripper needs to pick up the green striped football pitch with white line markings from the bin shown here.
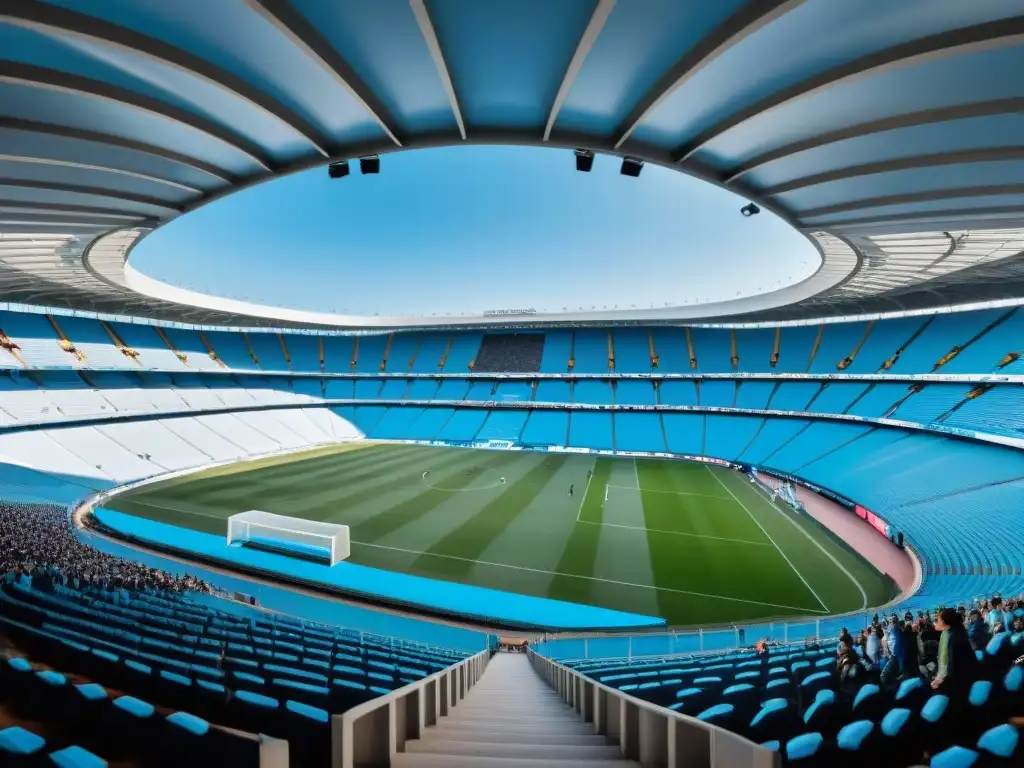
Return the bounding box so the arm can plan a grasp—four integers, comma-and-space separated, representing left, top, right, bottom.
108, 443, 896, 626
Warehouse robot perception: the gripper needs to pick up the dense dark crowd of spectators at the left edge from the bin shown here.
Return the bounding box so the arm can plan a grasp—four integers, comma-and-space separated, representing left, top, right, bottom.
0, 501, 209, 592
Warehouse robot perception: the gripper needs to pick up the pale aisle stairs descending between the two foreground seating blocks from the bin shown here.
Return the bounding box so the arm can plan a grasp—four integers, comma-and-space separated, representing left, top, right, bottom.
391, 653, 639, 768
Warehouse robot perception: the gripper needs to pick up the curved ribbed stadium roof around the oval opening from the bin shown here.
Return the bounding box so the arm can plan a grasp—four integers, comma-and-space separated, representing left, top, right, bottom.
0, 0, 1024, 326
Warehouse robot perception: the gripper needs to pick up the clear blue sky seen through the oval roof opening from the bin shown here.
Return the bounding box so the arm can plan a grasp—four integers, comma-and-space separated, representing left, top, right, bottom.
131, 146, 818, 315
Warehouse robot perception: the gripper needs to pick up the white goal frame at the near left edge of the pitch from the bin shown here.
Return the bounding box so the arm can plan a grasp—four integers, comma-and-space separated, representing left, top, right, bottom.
227, 510, 349, 565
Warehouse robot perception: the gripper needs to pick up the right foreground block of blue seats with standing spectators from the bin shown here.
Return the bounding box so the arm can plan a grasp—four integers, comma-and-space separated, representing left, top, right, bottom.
552, 600, 1024, 766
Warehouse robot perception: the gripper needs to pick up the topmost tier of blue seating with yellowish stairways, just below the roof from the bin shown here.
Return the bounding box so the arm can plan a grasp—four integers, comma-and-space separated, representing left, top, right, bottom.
0, 309, 1024, 374
